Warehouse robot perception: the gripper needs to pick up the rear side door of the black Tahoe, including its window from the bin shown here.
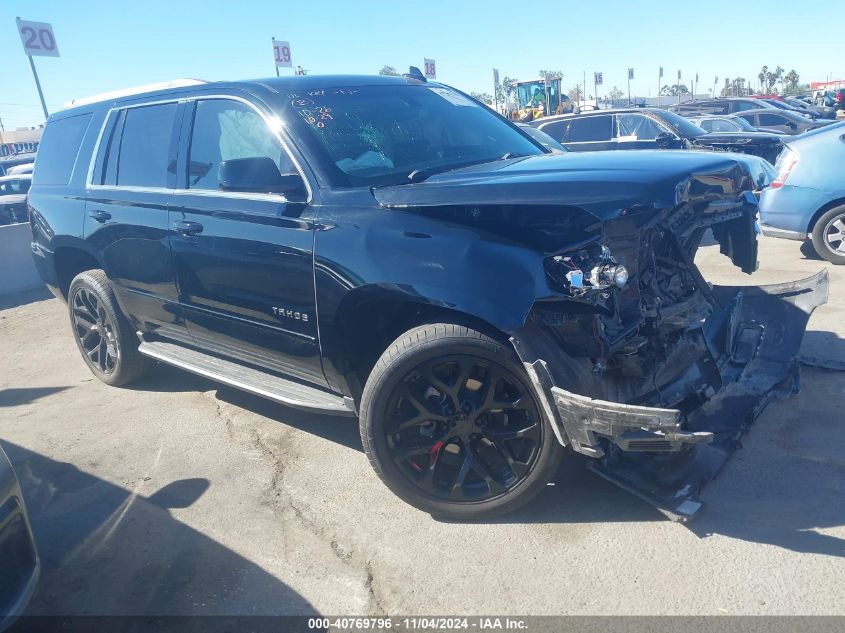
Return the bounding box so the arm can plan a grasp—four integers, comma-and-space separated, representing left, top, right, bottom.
84, 100, 185, 335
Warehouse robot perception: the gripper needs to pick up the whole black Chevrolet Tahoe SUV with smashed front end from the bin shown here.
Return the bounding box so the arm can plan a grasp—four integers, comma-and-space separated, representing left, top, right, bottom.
29, 73, 827, 519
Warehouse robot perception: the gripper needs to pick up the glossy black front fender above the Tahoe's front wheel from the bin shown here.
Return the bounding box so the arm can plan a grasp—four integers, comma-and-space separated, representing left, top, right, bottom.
314, 210, 552, 390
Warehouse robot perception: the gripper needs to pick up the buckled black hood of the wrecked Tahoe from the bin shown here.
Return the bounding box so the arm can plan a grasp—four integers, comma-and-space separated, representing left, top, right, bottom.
373, 150, 775, 220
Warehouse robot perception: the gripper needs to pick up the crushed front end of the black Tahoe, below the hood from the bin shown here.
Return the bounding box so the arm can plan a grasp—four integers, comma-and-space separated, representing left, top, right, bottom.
511, 166, 828, 520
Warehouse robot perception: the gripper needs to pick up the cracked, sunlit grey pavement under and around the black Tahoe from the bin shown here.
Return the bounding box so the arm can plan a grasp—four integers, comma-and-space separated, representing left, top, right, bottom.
0, 238, 845, 615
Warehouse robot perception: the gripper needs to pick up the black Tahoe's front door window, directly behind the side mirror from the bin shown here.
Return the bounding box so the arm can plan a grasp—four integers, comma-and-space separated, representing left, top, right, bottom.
188, 99, 296, 190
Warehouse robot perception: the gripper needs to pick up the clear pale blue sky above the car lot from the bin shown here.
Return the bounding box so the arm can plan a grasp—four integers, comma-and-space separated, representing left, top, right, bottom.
0, 0, 845, 129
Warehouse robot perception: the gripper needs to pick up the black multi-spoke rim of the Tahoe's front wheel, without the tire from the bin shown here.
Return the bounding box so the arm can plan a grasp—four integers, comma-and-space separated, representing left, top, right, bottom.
385, 355, 543, 501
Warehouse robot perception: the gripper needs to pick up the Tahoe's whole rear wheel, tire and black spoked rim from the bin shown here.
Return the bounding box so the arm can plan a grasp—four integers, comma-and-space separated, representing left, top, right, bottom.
67, 270, 154, 386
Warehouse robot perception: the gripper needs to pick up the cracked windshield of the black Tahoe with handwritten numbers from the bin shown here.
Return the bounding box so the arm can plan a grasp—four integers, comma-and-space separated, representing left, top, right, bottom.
284, 85, 545, 187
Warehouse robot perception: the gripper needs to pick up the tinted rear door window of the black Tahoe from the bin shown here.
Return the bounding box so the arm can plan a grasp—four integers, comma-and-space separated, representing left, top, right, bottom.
101, 103, 178, 187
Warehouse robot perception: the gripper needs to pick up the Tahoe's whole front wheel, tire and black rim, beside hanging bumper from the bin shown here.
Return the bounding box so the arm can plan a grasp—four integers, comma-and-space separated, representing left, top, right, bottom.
360, 323, 563, 520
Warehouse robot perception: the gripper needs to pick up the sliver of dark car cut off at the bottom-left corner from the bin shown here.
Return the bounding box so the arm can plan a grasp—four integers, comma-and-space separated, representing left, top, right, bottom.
0, 448, 40, 631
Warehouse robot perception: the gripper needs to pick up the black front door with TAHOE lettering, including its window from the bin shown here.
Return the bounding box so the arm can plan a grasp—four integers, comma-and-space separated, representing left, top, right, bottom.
170, 97, 326, 385
